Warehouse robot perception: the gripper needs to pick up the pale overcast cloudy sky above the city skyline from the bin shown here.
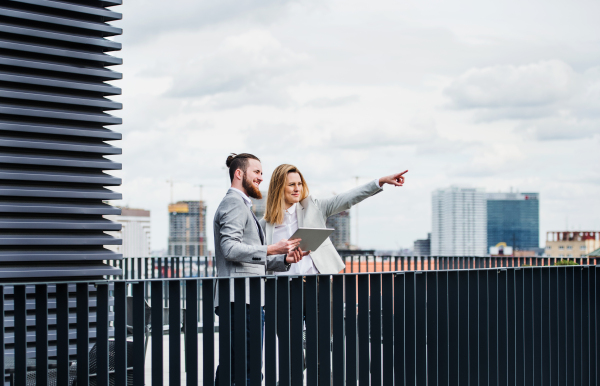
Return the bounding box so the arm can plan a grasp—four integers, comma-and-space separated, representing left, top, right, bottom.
106, 0, 600, 250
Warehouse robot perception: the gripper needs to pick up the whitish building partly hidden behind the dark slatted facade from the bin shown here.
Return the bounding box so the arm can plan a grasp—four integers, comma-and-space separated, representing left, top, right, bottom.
104, 207, 151, 257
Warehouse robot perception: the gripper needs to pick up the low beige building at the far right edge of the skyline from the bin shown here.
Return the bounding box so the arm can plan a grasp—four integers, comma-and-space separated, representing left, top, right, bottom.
546, 231, 600, 257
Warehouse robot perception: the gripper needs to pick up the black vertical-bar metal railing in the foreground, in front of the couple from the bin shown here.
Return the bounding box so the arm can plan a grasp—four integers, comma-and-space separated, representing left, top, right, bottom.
0, 266, 600, 386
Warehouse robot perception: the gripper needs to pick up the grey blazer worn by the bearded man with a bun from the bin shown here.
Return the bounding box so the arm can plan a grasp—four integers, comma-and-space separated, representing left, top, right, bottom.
214, 190, 289, 306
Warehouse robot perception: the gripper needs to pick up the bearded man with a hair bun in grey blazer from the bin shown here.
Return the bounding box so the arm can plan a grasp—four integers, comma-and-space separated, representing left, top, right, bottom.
214, 153, 308, 386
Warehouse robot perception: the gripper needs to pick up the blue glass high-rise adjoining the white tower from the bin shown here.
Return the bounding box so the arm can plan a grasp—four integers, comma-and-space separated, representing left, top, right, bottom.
486, 193, 540, 251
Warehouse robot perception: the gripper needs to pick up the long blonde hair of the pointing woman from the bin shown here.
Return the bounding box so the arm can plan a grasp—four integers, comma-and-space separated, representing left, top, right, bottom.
265, 164, 308, 225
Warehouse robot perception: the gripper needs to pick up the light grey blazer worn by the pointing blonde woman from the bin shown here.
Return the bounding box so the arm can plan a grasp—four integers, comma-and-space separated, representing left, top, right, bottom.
260, 181, 383, 275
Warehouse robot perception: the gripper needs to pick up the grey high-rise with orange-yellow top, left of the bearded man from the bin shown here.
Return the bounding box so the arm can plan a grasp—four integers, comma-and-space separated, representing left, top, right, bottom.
168, 201, 207, 256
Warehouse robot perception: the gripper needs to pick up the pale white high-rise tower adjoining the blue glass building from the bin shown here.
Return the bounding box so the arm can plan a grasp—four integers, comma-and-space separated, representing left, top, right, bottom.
431, 186, 487, 256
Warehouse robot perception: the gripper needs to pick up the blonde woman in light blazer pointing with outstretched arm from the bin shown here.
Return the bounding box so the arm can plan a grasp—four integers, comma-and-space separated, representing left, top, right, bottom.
260, 164, 408, 275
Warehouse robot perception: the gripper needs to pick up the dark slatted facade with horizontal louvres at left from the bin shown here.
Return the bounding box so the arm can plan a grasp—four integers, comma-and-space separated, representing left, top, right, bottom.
0, 0, 122, 281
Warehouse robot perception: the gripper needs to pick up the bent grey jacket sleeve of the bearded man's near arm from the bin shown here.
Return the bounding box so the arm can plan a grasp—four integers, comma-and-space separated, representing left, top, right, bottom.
218, 203, 267, 264
